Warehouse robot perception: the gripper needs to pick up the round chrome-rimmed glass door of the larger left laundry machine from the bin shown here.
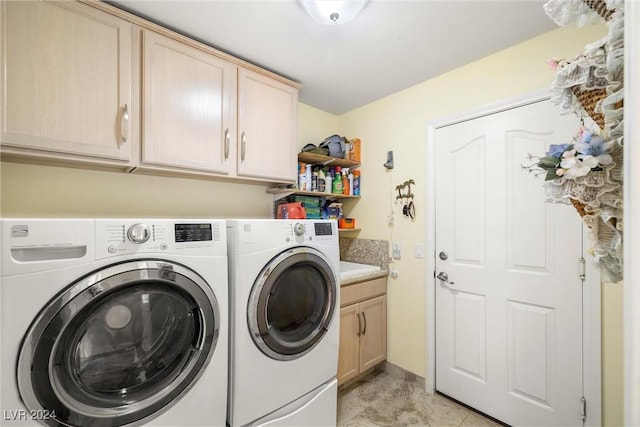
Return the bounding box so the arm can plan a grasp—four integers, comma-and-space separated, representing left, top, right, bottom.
18, 260, 219, 426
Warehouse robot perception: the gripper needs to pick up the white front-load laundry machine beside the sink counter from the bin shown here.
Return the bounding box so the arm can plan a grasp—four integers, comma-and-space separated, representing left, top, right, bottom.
227, 220, 340, 427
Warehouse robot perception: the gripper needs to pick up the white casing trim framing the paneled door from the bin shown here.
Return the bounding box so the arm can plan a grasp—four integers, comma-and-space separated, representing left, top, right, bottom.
425, 89, 602, 426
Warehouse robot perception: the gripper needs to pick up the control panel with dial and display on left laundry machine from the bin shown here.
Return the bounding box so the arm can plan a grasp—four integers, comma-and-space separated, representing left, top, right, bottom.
96, 219, 226, 258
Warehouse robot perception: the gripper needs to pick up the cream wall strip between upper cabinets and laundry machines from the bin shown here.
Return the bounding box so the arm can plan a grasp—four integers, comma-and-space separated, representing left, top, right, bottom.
1, 162, 271, 218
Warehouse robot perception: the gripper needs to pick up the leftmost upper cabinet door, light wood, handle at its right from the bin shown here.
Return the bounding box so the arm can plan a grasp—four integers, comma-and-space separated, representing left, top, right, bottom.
0, 1, 133, 163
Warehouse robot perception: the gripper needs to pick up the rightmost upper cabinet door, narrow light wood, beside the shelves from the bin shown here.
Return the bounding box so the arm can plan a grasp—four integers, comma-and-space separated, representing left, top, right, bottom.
238, 68, 298, 182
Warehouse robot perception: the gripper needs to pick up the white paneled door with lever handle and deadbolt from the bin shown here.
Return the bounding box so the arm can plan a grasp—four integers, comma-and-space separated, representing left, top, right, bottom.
435, 101, 582, 426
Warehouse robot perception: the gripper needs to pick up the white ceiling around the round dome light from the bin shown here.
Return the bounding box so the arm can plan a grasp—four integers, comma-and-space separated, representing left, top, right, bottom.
109, 0, 556, 114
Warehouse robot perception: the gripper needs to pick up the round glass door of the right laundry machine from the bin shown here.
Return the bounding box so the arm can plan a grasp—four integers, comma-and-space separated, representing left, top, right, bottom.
247, 247, 337, 360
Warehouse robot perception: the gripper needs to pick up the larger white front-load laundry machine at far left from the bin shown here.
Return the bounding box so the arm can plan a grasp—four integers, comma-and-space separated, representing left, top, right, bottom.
0, 219, 228, 427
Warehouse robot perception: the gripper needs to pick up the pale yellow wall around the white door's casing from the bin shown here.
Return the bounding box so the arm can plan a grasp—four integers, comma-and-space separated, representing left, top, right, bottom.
338, 26, 623, 425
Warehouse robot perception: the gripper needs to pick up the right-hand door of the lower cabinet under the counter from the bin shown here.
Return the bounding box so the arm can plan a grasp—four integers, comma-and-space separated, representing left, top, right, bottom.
360, 295, 387, 371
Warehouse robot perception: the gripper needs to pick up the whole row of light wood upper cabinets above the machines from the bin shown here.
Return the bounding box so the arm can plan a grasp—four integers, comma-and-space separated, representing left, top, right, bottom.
0, 0, 299, 183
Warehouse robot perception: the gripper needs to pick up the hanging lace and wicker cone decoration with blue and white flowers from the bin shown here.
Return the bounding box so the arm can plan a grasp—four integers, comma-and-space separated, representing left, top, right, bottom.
522, 0, 624, 282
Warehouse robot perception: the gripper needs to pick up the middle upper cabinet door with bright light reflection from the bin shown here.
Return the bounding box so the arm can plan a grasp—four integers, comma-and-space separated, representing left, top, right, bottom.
142, 31, 237, 174
